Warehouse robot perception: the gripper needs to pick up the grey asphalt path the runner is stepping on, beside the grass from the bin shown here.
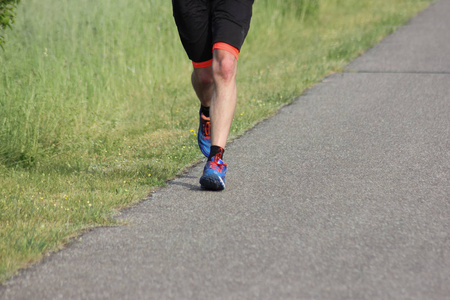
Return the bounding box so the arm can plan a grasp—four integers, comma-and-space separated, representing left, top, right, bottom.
0, 0, 450, 300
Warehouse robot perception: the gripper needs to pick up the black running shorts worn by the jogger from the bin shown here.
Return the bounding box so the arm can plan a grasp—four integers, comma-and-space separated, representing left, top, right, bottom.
172, 0, 254, 65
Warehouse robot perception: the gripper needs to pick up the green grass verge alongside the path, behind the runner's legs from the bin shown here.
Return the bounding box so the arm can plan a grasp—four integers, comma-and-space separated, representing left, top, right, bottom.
0, 0, 431, 282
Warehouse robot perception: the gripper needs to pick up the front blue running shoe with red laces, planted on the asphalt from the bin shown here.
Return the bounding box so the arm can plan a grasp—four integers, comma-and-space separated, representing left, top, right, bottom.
200, 157, 227, 191
